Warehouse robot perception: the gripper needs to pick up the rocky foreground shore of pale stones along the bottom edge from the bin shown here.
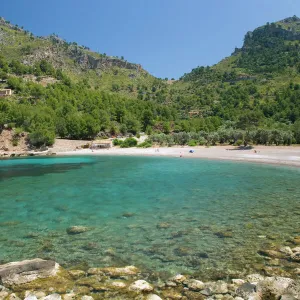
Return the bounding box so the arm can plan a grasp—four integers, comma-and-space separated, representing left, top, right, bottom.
0, 247, 300, 300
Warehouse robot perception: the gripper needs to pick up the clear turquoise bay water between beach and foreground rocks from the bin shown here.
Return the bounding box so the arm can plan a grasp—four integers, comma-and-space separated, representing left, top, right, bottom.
0, 156, 300, 277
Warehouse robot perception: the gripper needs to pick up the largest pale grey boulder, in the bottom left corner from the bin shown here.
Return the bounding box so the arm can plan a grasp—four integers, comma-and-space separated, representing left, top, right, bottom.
0, 258, 59, 285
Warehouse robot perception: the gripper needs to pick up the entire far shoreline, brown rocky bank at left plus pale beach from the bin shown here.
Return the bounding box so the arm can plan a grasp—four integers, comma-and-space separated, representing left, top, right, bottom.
0, 143, 300, 168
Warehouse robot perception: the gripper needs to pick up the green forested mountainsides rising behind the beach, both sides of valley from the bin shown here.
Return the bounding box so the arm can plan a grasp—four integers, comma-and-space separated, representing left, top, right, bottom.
0, 16, 300, 145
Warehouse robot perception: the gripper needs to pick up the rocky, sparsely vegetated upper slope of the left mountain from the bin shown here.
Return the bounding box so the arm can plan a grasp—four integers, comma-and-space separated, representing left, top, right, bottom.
0, 18, 166, 97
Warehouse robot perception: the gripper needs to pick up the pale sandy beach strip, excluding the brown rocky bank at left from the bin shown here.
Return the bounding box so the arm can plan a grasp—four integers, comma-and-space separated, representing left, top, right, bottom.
52, 146, 300, 167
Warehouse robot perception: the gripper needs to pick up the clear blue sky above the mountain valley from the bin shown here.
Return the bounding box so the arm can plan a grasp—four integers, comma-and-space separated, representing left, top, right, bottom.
0, 0, 300, 79
